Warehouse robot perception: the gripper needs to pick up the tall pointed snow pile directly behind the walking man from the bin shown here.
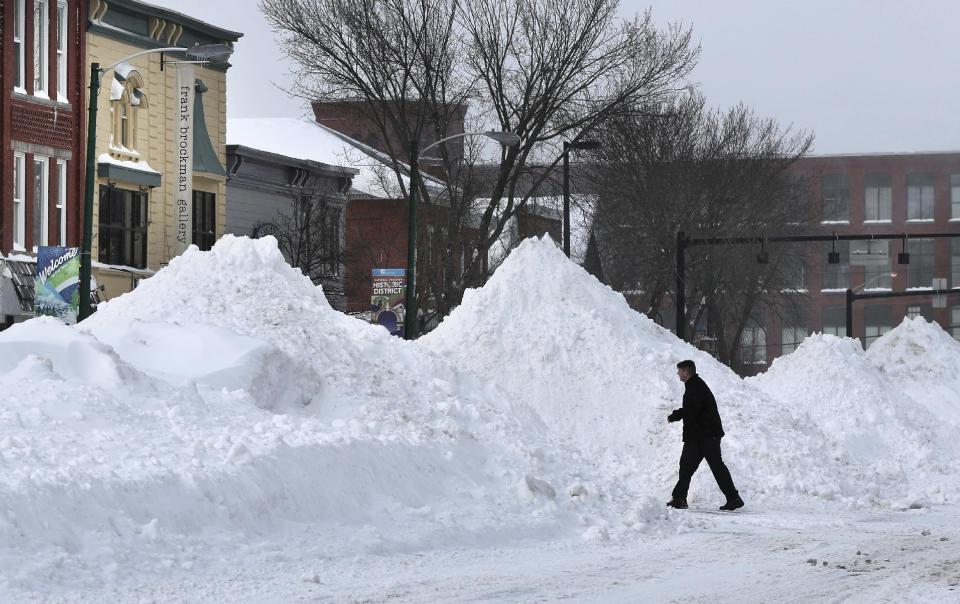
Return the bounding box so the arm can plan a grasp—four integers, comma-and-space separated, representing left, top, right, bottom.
421, 237, 853, 501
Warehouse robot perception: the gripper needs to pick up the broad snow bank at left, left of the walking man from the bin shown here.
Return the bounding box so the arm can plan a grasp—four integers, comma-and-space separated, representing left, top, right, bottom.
0, 236, 676, 599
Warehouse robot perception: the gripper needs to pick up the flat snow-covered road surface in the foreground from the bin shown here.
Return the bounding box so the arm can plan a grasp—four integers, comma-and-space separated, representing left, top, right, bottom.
33, 506, 960, 603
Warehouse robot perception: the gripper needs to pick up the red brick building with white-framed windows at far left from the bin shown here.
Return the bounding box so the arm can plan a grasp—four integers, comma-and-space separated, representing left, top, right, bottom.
0, 0, 86, 324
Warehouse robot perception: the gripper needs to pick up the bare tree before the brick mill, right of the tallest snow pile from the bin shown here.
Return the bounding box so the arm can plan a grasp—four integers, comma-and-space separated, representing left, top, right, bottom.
594, 94, 813, 370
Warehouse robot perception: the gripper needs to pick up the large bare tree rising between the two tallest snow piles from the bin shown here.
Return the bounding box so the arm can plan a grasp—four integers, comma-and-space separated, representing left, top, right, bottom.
261, 0, 699, 324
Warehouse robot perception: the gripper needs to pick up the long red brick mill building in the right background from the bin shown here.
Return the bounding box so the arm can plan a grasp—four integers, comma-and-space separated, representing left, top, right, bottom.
744, 152, 960, 365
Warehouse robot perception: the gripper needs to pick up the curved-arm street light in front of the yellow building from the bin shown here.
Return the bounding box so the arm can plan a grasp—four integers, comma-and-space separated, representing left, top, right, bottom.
78, 44, 233, 321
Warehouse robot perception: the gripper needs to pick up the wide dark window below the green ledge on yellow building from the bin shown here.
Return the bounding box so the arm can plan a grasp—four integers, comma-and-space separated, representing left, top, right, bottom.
99, 186, 147, 268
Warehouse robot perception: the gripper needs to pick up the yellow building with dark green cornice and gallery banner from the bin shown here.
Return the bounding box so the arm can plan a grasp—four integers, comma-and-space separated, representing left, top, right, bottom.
86, 0, 242, 299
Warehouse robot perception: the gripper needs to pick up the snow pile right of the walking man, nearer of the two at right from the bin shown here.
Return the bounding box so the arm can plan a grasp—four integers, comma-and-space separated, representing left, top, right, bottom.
747, 334, 960, 506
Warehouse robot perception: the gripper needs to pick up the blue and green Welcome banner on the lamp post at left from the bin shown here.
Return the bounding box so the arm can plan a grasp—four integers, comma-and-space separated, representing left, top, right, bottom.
33, 246, 80, 325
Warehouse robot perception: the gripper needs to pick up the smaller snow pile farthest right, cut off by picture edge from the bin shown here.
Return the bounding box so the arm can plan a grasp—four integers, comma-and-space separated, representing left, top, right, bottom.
867, 317, 960, 426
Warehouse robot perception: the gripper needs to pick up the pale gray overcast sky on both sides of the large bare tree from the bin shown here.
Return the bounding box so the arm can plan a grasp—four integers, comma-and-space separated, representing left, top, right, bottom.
147, 0, 960, 153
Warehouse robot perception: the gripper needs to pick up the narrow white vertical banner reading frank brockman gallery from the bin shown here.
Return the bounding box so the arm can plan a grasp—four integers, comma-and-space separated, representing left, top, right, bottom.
173, 65, 195, 256
